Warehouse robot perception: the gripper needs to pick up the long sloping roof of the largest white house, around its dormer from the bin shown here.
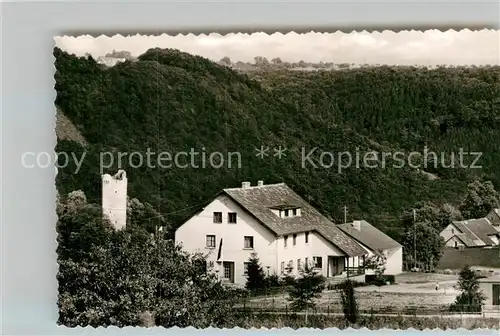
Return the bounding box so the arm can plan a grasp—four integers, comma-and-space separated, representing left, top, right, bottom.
222, 183, 366, 256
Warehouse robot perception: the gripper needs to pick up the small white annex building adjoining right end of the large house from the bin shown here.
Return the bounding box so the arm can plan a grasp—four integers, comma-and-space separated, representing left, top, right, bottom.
338, 220, 403, 275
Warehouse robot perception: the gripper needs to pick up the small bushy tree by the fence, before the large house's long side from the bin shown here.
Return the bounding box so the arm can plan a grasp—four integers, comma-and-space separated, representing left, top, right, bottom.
288, 265, 326, 324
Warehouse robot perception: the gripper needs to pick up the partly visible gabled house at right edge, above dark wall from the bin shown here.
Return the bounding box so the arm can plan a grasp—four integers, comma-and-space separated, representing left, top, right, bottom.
440, 214, 500, 248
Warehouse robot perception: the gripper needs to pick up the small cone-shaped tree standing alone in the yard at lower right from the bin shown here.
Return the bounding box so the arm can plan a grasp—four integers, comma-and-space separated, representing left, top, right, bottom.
450, 266, 485, 312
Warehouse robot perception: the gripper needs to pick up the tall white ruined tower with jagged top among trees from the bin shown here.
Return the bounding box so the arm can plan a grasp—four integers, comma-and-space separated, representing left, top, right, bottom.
102, 170, 127, 230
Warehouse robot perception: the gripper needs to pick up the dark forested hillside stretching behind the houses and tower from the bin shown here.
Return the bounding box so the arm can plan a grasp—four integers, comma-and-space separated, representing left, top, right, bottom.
54, 48, 500, 242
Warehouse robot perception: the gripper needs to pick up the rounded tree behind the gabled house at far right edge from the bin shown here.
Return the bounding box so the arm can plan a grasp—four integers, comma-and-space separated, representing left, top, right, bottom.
460, 180, 500, 219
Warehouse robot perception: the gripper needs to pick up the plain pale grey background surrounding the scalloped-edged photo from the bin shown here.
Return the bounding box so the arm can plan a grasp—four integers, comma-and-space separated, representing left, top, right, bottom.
0, 0, 499, 335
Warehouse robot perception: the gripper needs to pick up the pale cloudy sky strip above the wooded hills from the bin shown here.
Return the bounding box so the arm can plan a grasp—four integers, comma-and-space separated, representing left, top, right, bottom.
55, 29, 500, 65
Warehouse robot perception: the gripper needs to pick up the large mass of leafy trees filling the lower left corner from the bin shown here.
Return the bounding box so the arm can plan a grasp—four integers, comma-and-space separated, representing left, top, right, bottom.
58, 195, 238, 328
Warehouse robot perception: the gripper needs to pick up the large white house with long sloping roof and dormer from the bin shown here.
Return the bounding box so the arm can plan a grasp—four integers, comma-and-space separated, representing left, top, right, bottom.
175, 181, 402, 285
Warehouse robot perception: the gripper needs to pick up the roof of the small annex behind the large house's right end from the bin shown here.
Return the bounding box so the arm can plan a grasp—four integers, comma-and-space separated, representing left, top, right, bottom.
337, 220, 401, 251
